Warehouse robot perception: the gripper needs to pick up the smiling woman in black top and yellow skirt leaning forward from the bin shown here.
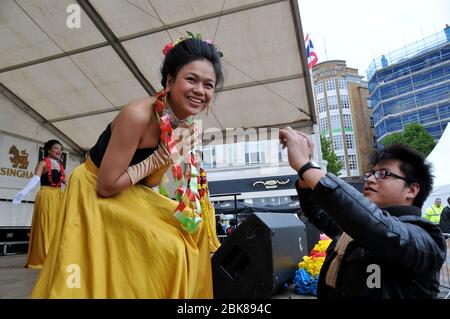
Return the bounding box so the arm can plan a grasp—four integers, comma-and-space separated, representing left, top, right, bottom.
32, 37, 223, 298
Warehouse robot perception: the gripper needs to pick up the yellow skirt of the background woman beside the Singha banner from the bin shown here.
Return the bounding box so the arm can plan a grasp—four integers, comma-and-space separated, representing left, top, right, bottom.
25, 186, 63, 268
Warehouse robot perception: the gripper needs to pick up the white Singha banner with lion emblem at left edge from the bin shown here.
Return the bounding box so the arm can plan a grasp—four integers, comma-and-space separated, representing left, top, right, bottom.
0, 134, 39, 189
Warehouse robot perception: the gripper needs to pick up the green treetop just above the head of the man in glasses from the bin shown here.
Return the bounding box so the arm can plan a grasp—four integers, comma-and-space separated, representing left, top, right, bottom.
381, 123, 436, 156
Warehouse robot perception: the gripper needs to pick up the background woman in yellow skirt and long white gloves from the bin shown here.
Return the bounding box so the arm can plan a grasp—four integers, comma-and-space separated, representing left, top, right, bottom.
13, 140, 64, 268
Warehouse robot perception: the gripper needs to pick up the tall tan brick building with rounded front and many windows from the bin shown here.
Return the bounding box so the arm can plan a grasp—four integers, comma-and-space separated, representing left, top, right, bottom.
313, 60, 374, 177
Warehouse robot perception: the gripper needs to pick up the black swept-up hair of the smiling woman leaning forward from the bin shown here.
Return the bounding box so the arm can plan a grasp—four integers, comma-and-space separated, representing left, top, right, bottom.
161, 38, 223, 90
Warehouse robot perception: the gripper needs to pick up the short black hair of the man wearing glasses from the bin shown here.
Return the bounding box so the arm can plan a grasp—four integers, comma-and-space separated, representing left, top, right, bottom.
370, 144, 434, 208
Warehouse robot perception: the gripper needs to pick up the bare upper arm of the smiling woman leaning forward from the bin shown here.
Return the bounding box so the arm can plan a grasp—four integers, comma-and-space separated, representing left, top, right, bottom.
97, 100, 156, 197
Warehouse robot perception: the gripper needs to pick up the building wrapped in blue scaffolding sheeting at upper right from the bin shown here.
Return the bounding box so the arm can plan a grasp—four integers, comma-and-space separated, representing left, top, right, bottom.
367, 27, 450, 144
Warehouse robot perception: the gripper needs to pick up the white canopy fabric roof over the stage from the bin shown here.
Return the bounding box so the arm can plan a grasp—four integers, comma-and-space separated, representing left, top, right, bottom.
0, 0, 315, 153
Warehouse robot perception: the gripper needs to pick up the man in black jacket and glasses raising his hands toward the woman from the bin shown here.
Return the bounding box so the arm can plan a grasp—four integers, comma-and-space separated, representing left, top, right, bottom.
280, 128, 446, 299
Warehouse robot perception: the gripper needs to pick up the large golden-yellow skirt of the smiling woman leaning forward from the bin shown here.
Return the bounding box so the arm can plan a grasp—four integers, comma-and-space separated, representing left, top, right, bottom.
31, 160, 213, 298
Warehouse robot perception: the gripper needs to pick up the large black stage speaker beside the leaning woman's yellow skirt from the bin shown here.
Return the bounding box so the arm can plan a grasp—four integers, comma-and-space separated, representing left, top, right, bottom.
212, 213, 308, 299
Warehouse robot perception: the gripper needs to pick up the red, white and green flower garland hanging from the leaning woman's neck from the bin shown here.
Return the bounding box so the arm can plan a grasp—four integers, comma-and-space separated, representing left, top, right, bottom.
154, 90, 206, 233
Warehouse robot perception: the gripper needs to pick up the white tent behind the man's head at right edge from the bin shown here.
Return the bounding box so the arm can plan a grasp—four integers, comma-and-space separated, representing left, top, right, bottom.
422, 125, 450, 215
